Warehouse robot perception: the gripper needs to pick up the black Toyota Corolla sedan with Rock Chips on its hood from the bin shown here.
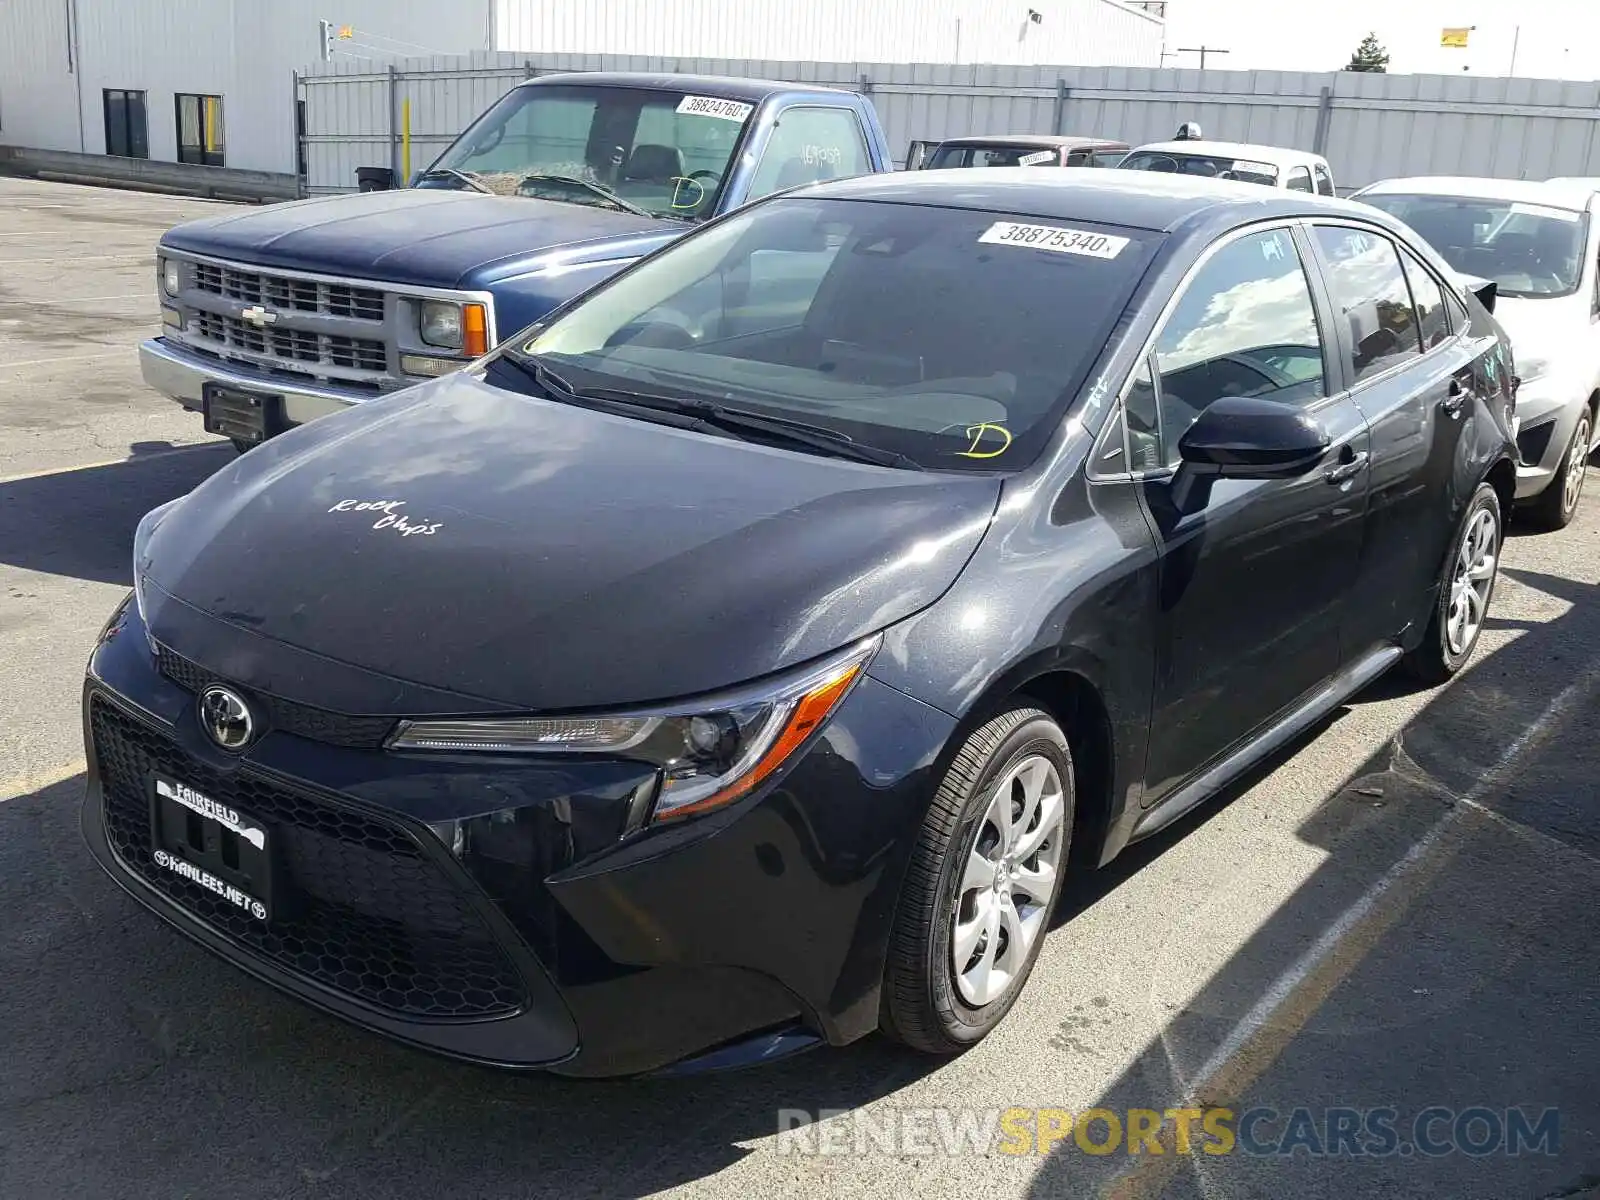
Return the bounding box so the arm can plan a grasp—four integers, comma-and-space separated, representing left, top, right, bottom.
83, 168, 1515, 1075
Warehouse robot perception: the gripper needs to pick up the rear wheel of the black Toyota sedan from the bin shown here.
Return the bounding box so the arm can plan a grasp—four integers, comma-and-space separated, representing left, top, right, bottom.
1405, 483, 1506, 686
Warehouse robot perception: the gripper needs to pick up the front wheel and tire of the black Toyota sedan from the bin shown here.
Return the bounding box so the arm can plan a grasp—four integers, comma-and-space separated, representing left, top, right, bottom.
882, 704, 1075, 1054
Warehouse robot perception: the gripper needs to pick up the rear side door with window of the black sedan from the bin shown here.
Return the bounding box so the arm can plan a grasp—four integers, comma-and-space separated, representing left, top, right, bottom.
1310, 221, 1482, 653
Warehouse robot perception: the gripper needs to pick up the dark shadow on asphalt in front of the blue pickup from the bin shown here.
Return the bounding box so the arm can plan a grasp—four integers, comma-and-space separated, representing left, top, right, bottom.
0, 442, 237, 586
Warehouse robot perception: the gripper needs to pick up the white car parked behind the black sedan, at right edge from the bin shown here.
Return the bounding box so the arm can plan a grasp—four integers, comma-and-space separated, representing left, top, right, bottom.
1357, 178, 1600, 530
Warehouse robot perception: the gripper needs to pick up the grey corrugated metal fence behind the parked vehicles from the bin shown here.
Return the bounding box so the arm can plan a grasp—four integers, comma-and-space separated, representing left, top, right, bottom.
301, 53, 1600, 194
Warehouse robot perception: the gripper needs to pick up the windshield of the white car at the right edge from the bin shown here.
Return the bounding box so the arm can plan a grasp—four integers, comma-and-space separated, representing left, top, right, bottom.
1362, 192, 1589, 299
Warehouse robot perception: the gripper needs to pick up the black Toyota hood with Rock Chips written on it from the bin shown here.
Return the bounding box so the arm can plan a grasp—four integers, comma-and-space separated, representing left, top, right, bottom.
144, 373, 1000, 714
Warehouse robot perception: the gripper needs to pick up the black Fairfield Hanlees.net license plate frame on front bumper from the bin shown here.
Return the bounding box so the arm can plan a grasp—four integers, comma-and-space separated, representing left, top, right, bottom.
149, 773, 275, 925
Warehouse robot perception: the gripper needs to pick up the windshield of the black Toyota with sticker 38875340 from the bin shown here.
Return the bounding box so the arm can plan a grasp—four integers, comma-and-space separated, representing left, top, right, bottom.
509, 197, 1160, 470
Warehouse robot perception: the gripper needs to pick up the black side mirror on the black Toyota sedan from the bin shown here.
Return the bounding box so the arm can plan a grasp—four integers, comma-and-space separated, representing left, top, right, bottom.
1173, 395, 1331, 512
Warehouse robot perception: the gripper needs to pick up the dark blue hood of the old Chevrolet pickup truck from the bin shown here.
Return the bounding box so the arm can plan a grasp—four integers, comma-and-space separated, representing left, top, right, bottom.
162, 189, 685, 288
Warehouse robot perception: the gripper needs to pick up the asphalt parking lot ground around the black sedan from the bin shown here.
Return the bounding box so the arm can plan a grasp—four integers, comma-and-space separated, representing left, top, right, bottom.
0, 178, 1600, 1200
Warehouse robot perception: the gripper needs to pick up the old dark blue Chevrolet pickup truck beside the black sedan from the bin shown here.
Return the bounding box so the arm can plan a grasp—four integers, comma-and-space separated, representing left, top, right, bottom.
139, 74, 893, 450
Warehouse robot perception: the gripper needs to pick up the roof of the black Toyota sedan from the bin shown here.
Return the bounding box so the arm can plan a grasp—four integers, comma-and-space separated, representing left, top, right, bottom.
795, 166, 1382, 232
